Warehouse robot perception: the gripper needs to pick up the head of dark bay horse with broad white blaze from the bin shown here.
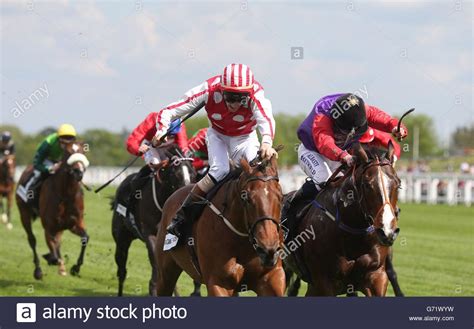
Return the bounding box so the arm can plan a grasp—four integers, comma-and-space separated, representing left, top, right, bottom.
347, 143, 400, 246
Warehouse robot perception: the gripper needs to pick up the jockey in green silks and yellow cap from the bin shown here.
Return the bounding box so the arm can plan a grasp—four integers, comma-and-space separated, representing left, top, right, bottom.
17, 123, 77, 202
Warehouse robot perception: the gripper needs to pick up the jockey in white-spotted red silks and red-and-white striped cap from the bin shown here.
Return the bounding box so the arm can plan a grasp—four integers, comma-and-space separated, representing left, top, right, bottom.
154, 64, 277, 237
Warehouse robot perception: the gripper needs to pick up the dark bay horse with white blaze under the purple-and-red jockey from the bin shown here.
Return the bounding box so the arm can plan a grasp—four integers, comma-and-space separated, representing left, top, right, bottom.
285, 144, 400, 296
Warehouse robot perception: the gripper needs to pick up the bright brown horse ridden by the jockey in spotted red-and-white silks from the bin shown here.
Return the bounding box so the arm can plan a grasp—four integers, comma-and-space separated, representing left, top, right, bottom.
155, 158, 285, 296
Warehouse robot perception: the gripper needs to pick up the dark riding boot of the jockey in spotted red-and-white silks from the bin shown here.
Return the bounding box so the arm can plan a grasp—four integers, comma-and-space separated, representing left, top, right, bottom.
166, 184, 206, 237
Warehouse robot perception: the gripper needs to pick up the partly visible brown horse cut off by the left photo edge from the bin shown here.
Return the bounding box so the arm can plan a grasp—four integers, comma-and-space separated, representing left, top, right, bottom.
0, 155, 15, 230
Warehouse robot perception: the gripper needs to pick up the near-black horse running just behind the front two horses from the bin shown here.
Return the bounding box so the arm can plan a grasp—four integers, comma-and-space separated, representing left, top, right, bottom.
112, 143, 196, 296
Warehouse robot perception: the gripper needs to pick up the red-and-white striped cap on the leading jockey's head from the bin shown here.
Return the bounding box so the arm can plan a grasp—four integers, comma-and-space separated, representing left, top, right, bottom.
221, 63, 254, 92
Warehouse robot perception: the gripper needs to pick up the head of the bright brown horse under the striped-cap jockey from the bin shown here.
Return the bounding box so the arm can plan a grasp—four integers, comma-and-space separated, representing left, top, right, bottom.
238, 152, 283, 267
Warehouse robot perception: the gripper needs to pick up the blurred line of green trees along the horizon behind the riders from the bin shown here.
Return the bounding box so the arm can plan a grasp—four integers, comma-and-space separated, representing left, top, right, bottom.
0, 113, 474, 166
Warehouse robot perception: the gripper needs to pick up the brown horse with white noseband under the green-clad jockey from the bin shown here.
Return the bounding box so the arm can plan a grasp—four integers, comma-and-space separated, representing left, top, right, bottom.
16, 143, 89, 280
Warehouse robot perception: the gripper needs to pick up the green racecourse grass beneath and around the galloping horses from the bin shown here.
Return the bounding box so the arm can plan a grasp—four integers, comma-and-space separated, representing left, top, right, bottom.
0, 189, 474, 296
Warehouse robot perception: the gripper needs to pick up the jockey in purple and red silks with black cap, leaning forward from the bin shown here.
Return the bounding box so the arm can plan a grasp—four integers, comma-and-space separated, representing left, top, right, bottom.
291, 93, 408, 210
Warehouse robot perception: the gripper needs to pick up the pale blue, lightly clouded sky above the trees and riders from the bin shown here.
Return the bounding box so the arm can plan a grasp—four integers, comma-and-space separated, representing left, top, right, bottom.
0, 0, 474, 140
